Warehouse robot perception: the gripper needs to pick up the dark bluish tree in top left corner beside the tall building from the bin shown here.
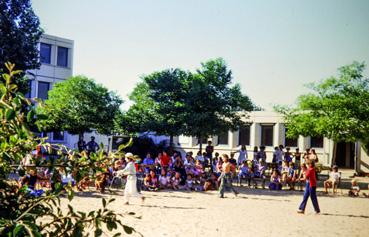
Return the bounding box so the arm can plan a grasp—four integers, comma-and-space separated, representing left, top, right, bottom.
0, 0, 43, 92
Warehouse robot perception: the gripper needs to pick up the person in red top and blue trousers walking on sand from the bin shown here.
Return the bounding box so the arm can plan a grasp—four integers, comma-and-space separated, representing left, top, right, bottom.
297, 161, 320, 214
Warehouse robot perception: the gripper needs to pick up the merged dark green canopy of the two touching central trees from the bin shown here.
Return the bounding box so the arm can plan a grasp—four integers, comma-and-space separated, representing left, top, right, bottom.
120, 59, 256, 149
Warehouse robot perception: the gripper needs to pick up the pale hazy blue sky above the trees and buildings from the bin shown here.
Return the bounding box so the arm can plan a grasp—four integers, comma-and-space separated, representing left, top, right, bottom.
32, 0, 369, 110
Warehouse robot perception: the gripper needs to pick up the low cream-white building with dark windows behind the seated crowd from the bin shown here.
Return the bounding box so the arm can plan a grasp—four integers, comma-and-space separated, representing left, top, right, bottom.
174, 111, 369, 173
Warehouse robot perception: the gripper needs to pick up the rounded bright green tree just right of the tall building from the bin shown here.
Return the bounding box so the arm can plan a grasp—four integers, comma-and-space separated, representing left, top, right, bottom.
38, 76, 122, 137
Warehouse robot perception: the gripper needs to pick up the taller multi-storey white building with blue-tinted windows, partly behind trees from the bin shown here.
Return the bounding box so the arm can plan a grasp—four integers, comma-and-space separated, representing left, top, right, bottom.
26, 34, 108, 148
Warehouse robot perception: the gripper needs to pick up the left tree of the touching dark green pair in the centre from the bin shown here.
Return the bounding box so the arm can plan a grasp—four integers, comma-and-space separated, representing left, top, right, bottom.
118, 69, 188, 145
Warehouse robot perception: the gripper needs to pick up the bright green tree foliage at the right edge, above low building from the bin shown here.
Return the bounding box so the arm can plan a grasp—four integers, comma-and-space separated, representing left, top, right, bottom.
276, 62, 369, 150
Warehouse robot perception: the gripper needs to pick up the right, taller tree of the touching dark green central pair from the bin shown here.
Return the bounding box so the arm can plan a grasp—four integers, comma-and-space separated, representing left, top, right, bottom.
184, 58, 256, 151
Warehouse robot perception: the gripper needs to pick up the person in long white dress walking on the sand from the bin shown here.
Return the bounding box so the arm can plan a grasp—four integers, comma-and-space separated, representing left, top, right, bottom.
121, 153, 145, 205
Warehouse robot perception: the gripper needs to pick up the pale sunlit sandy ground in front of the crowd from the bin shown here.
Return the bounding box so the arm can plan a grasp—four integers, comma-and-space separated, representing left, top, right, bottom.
63, 187, 369, 237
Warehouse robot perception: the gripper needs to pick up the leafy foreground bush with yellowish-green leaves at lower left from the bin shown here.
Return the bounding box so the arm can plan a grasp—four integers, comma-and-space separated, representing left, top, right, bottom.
0, 63, 134, 236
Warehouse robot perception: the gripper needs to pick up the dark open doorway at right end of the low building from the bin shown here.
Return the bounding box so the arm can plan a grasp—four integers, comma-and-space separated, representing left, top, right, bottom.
335, 142, 355, 169
